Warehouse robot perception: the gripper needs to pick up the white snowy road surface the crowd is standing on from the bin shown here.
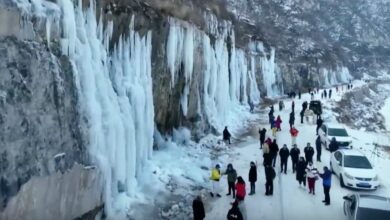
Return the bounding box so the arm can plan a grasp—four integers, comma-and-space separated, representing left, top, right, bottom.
206, 86, 389, 220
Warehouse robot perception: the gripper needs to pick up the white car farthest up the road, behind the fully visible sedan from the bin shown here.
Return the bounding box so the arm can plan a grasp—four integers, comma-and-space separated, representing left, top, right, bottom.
318, 124, 352, 150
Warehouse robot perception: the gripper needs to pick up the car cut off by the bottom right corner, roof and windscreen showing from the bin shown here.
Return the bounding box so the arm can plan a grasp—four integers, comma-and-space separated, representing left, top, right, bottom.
343, 194, 390, 220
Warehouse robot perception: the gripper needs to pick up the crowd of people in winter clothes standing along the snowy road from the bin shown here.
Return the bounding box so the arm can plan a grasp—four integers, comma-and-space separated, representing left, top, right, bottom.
193, 85, 352, 220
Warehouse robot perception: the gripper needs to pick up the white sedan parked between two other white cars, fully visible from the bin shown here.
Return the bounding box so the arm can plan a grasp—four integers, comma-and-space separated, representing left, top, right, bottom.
330, 149, 379, 190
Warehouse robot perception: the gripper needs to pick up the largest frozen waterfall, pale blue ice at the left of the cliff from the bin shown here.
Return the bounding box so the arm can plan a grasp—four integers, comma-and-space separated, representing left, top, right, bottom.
60, 0, 154, 215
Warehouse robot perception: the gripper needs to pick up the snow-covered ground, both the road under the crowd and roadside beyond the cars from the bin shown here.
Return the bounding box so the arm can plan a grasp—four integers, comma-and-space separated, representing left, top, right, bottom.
206, 81, 390, 220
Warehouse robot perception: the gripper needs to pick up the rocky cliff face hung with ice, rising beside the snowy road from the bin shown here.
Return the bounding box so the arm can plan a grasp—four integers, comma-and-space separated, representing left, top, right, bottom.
0, 0, 390, 219
